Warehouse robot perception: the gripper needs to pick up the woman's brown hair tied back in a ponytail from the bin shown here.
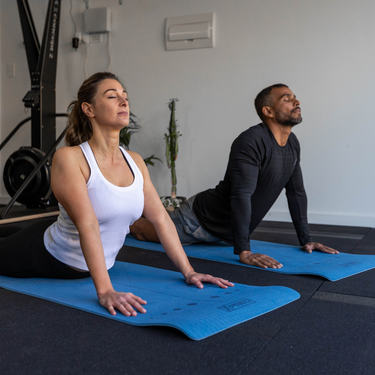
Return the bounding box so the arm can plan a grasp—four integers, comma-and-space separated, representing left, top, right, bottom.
65, 72, 125, 146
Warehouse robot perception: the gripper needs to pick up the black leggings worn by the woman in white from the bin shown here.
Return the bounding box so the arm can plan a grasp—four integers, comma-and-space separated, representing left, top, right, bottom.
0, 218, 90, 279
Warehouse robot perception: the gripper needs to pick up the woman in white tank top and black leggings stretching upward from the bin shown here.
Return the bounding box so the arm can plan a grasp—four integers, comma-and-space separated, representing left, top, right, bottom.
0, 72, 233, 316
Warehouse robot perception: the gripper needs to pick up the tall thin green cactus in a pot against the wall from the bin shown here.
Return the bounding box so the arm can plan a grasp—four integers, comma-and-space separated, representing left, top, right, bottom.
161, 99, 185, 210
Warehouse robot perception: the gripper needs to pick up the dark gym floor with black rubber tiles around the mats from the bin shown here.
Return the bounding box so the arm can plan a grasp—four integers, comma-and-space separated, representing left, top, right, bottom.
0, 217, 375, 375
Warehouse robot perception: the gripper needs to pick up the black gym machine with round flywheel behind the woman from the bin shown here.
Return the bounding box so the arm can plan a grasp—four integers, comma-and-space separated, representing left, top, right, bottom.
0, 0, 67, 219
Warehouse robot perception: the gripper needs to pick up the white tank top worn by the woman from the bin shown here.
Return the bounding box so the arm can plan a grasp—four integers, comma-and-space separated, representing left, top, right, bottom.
44, 142, 144, 271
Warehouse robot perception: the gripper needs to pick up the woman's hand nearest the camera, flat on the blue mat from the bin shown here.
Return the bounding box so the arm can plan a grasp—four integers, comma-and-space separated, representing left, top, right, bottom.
99, 290, 147, 316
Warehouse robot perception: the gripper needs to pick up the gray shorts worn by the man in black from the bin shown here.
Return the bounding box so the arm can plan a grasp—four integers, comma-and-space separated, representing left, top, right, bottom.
168, 195, 220, 245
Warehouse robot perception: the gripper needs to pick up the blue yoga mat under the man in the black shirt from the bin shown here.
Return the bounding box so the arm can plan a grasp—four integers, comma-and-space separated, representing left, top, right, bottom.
125, 236, 375, 281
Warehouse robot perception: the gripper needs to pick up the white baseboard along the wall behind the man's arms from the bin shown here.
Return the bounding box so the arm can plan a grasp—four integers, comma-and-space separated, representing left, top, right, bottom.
264, 210, 375, 228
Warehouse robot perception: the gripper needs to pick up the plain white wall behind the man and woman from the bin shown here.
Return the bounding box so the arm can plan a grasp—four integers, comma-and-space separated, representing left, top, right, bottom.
0, 0, 375, 227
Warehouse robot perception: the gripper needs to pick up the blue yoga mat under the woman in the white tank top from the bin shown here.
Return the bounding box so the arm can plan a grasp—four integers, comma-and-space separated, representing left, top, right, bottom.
0, 262, 300, 340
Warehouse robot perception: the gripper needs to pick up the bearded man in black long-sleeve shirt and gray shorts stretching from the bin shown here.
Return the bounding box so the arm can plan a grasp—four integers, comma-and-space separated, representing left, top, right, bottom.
131, 84, 338, 268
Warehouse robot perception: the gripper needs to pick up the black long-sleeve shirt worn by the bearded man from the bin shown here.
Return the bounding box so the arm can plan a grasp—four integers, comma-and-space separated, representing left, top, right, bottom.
193, 123, 311, 254
